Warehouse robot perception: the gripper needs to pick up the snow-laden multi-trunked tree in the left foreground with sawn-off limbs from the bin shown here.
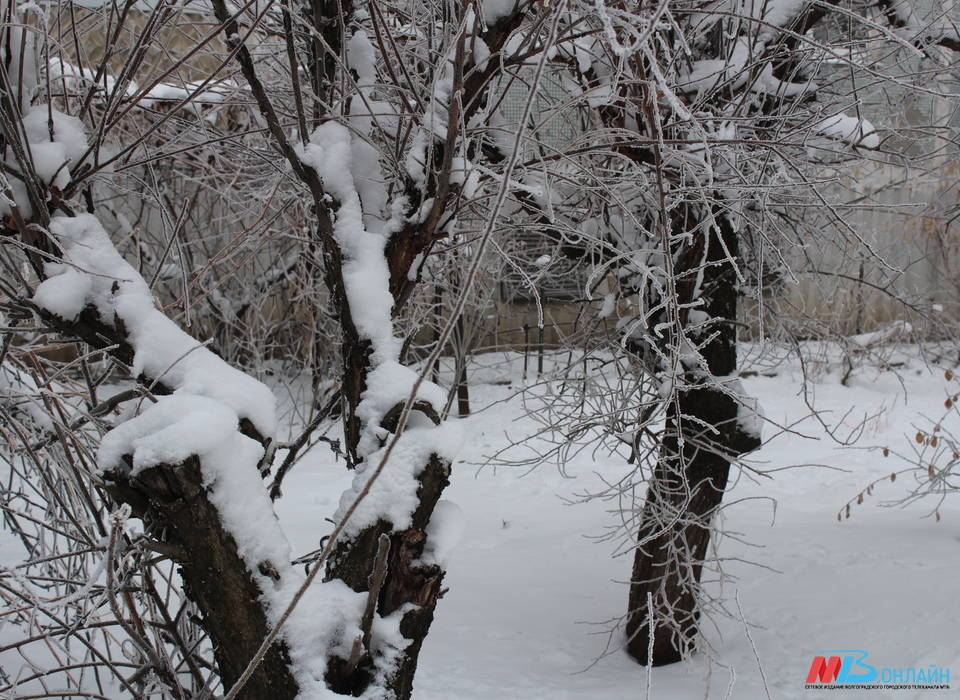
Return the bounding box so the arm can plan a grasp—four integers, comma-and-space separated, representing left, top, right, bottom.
2, 1, 540, 698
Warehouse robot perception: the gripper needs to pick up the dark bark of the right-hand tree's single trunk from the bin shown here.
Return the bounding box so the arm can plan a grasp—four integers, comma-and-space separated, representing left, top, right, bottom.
627, 211, 760, 666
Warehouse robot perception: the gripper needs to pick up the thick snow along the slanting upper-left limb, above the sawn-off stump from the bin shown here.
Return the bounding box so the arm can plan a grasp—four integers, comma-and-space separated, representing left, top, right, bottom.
33, 214, 276, 436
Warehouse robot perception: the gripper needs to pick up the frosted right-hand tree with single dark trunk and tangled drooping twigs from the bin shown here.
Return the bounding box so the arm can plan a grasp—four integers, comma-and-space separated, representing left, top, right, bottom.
476, 0, 958, 665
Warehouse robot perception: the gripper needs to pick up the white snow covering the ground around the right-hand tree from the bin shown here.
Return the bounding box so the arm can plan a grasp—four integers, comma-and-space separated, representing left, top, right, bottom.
272, 346, 960, 700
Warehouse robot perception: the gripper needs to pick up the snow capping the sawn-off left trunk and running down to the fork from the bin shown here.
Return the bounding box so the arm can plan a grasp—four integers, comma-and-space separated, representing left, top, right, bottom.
98, 394, 372, 700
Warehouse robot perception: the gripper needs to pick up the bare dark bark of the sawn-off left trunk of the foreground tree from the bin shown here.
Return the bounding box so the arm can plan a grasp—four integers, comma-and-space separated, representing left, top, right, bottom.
105, 457, 298, 700
